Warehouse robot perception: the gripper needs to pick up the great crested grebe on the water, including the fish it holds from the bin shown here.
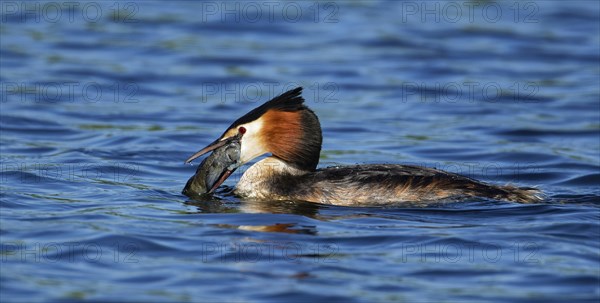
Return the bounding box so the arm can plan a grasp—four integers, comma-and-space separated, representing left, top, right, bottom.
183, 87, 541, 205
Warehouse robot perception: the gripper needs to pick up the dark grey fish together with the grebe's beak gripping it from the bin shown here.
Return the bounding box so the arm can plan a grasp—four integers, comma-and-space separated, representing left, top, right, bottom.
182, 134, 242, 196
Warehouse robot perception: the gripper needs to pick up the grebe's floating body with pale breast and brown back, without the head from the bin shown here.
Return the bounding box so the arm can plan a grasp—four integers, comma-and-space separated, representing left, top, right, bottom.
234, 158, 540, 206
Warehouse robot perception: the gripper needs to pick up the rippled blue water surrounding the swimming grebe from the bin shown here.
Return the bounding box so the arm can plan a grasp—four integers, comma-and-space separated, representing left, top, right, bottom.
0, 1, 600, 302
